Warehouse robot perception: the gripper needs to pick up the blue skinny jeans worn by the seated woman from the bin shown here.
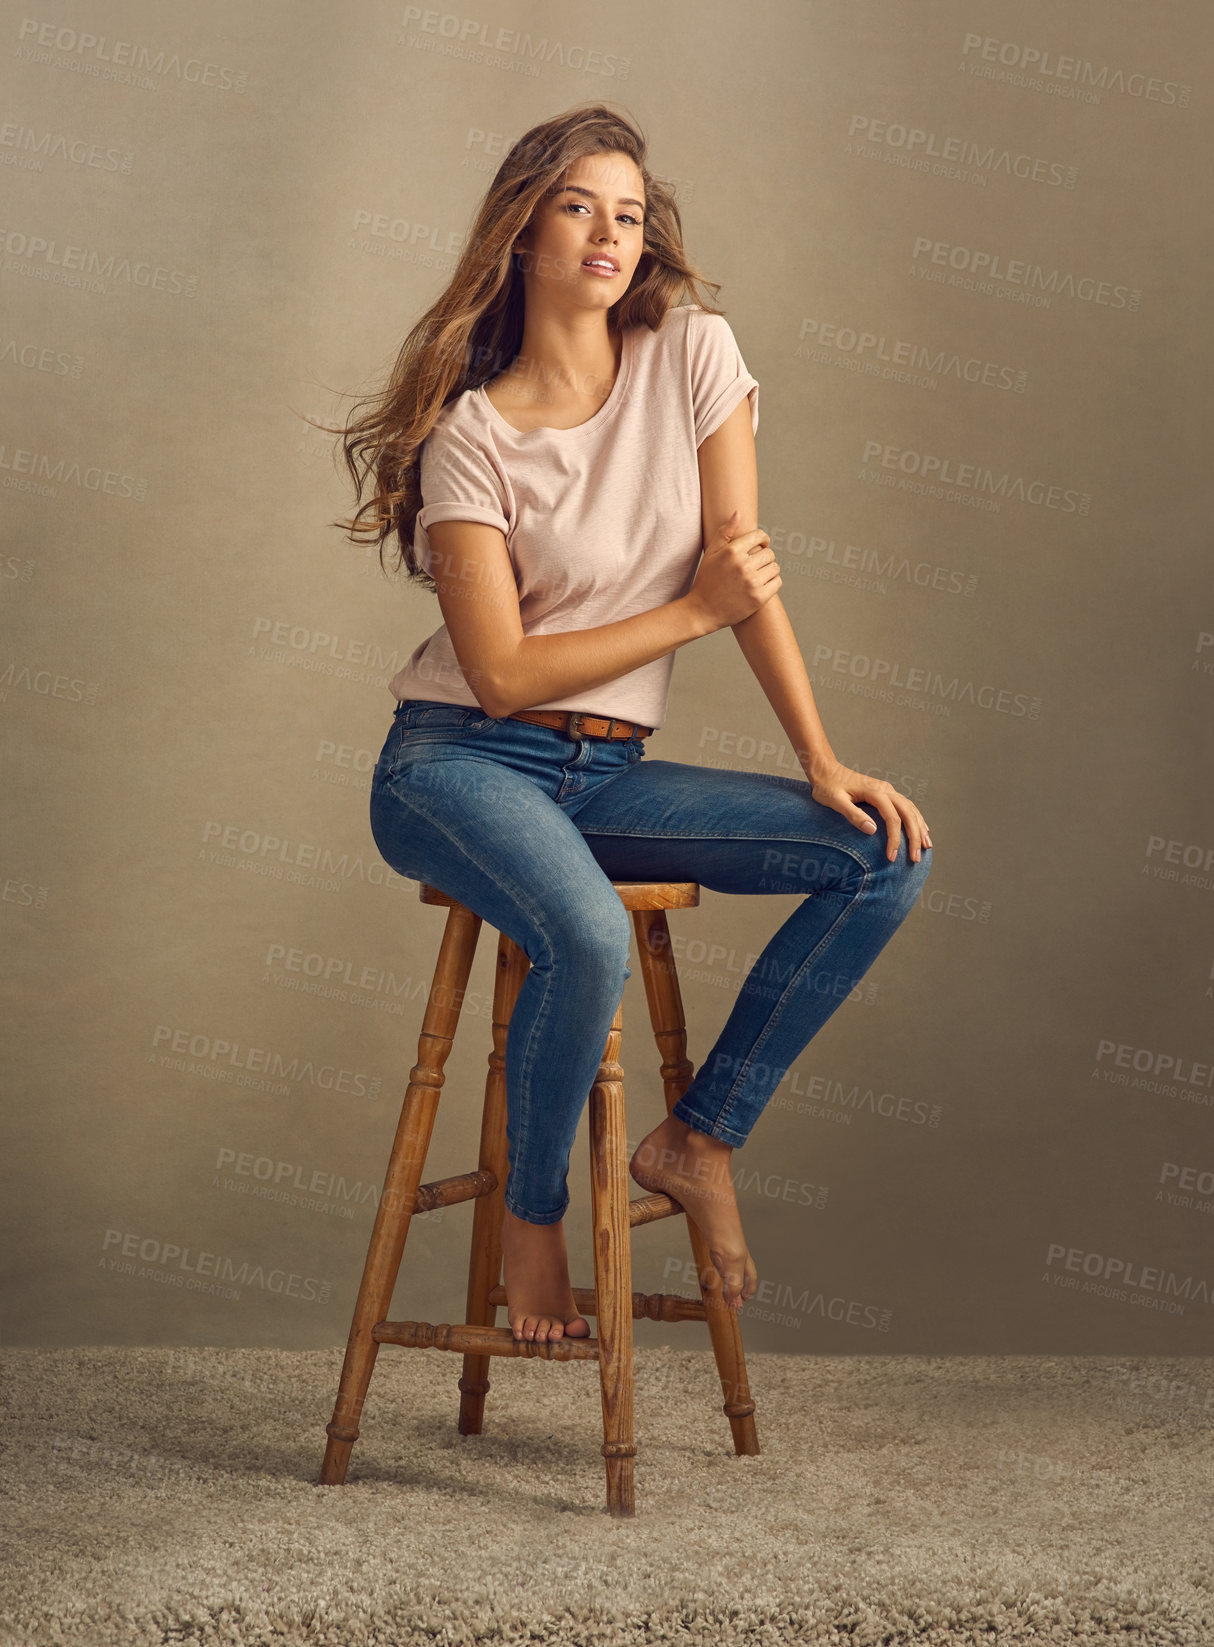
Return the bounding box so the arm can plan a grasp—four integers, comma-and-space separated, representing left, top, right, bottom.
371, 698, 931, 1224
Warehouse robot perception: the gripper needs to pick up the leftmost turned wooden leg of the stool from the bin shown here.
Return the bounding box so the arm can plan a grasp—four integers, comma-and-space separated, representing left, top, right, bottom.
320, 904, 481, 1487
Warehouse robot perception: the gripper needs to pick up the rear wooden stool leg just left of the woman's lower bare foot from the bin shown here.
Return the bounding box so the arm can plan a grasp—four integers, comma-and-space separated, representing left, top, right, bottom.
460, 932, 530, 1436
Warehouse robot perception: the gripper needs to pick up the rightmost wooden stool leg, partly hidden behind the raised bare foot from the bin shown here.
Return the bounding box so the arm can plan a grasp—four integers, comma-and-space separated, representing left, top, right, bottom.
633, 909, 759, 1458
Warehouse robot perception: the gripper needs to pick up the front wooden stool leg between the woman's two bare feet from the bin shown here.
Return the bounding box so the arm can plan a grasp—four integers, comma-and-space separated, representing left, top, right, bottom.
590, 1001, 636, 1517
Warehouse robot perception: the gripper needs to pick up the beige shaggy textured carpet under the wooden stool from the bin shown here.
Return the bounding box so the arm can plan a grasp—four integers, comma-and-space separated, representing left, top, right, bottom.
0, 1347, 1214, 1647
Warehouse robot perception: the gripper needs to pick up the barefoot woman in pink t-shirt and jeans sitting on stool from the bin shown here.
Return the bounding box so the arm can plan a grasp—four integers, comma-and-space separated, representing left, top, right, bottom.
338, 104, 931, 1342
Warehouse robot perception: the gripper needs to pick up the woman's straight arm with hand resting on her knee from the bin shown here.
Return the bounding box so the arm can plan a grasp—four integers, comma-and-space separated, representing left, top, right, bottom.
698, 399, 931, 863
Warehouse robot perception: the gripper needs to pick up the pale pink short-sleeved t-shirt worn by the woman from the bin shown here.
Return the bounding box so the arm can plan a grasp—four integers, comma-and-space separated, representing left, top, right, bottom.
389, 303, 759, 728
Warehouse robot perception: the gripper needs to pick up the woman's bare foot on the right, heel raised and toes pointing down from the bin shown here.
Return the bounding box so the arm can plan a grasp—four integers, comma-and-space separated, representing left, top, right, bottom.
628, 1115, 759, 1309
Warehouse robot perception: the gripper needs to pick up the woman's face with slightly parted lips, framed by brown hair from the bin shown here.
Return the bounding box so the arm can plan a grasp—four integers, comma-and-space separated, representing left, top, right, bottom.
516, 153, 646, 310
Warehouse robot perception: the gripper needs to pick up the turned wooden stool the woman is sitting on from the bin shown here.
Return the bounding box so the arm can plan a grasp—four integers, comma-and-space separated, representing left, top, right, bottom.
320, 881, 759, 1515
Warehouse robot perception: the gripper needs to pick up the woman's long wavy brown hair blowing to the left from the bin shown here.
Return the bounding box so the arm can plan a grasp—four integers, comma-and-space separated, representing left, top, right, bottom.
317, 102, 723, 591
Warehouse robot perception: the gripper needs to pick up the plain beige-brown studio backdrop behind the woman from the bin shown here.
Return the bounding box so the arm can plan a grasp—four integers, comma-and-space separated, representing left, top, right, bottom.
0, 0, 1214, 1376
